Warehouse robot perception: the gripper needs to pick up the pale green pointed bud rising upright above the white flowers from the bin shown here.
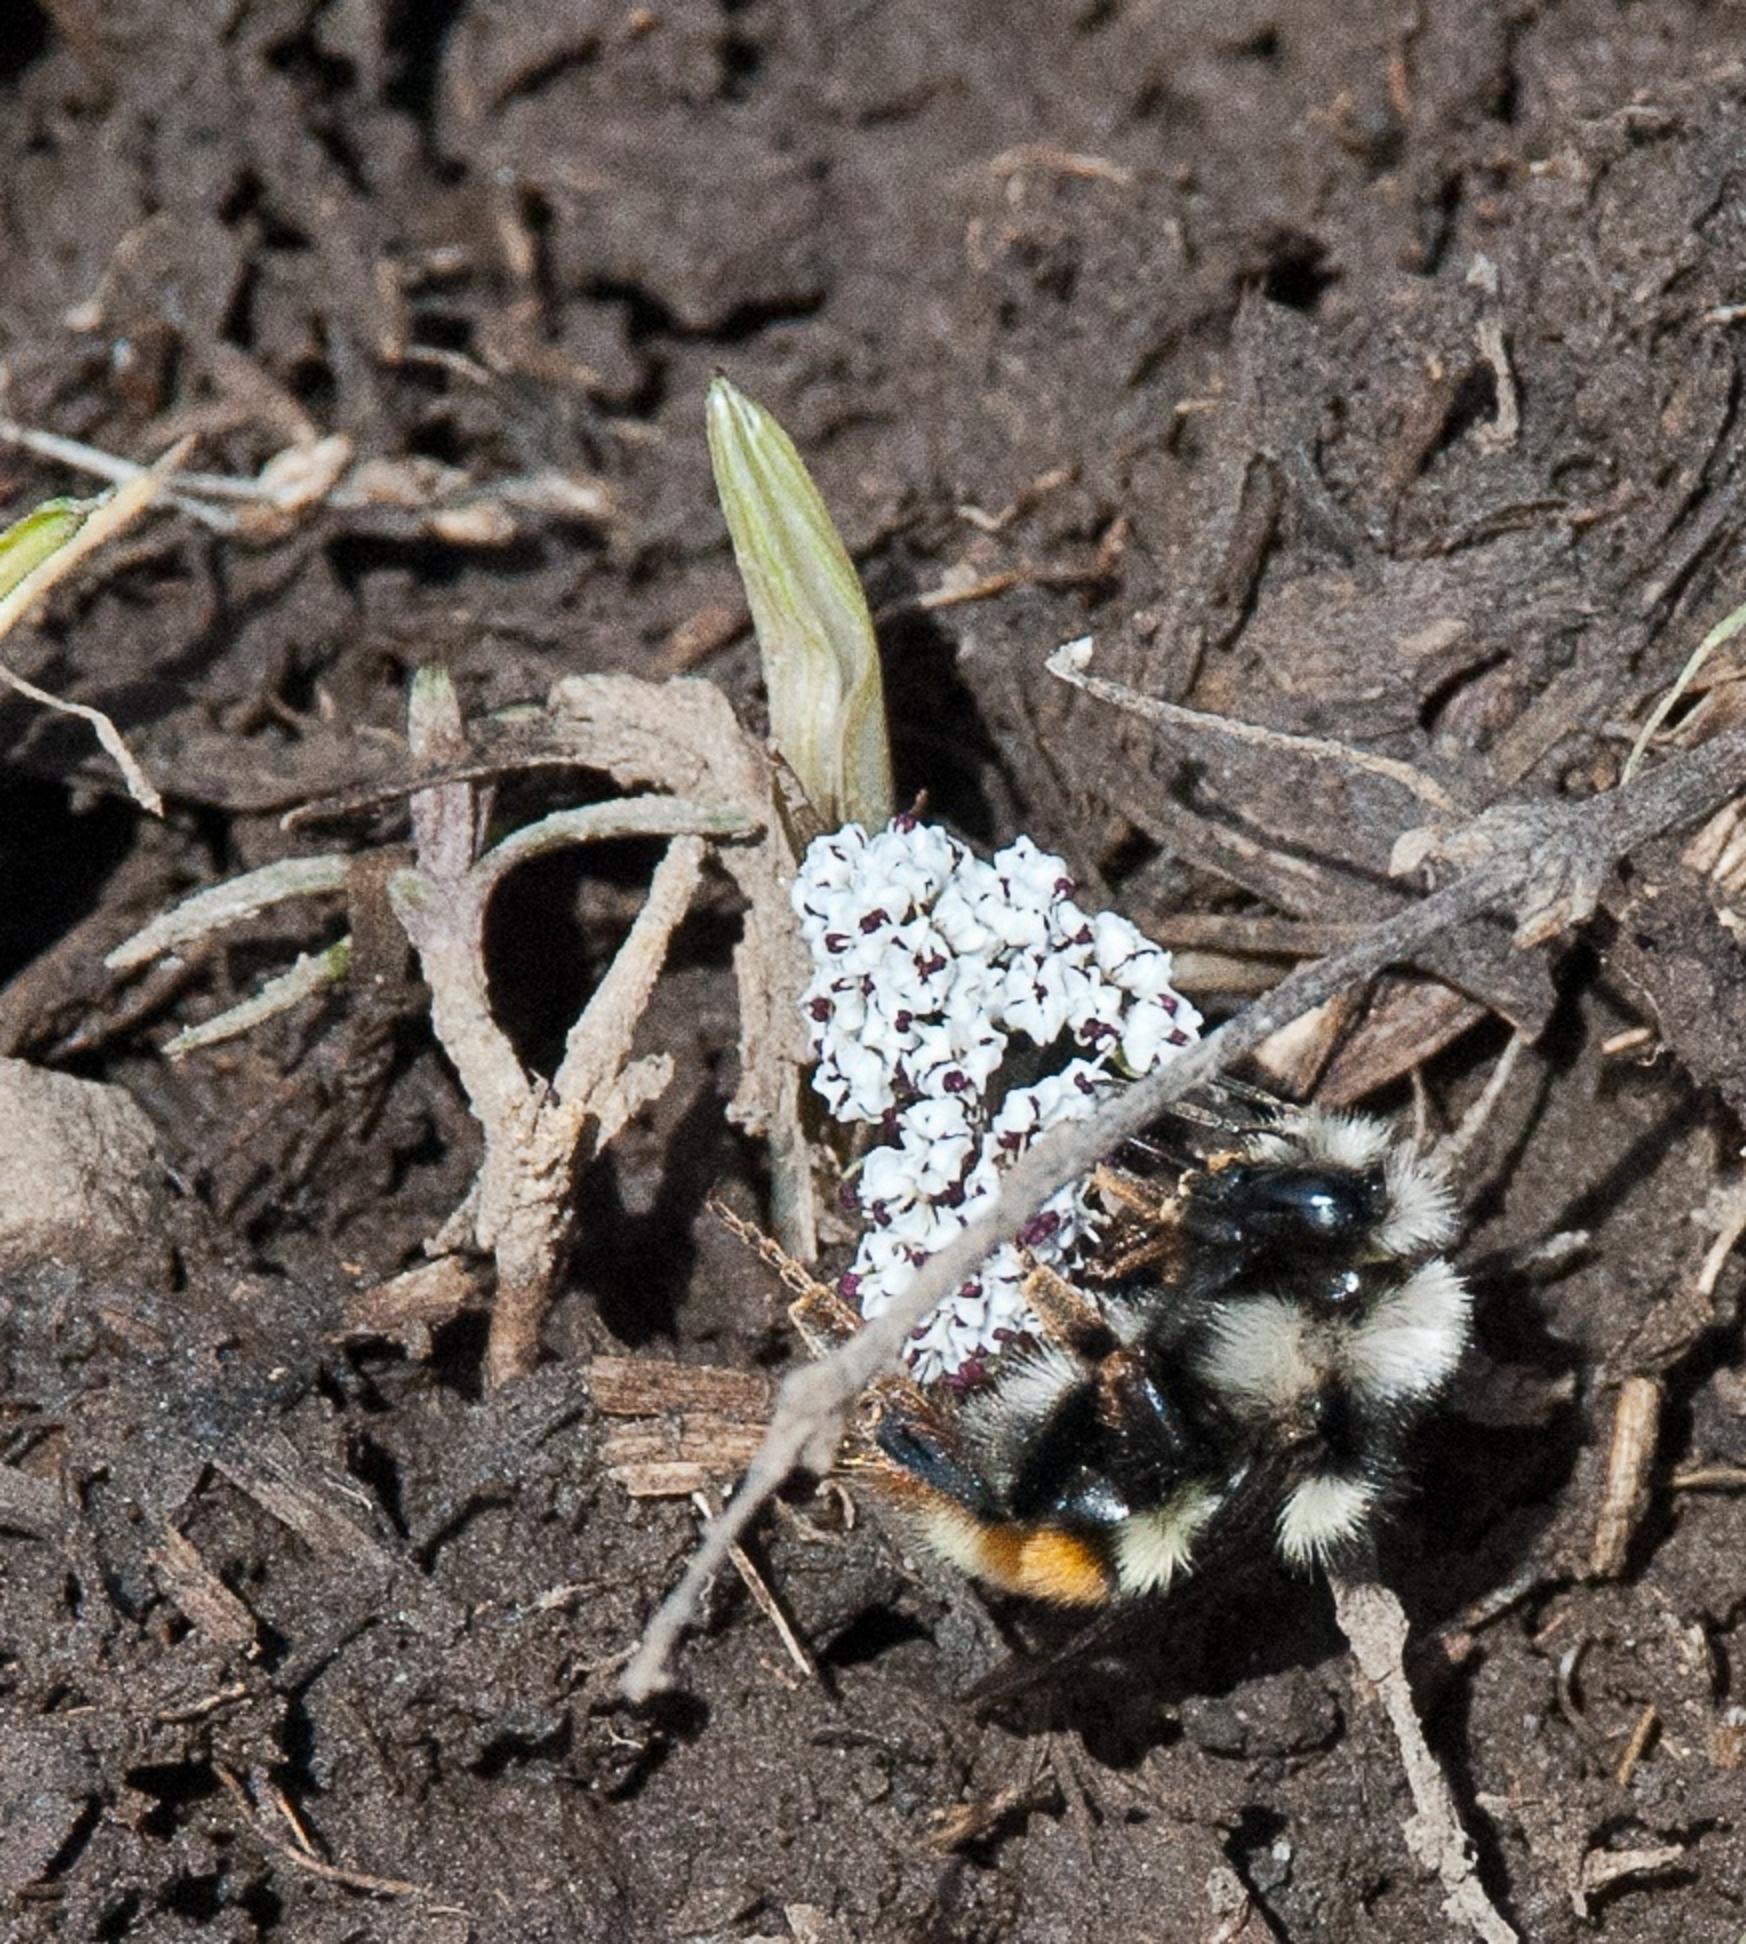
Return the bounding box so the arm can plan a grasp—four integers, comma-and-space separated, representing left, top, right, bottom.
708, 377, 892, 830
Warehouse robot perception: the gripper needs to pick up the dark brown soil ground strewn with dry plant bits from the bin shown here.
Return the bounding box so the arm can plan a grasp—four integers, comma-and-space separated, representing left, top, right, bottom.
0, 0, 1746, 1944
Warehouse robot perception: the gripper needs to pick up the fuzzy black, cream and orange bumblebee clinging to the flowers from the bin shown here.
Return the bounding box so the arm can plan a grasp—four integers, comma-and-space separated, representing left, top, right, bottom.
867, 1085, 1470, 1608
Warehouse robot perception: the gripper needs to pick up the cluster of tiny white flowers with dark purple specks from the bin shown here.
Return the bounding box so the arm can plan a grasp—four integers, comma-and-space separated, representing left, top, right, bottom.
793, 816, 1200, 1384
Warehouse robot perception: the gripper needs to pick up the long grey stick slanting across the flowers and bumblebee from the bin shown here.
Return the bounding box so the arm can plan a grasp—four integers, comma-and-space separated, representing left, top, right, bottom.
624, 729, 1746, 1701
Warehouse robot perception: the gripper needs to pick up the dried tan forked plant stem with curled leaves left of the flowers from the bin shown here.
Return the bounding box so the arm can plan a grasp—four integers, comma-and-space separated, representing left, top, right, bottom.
107, 671, 817, 1384
